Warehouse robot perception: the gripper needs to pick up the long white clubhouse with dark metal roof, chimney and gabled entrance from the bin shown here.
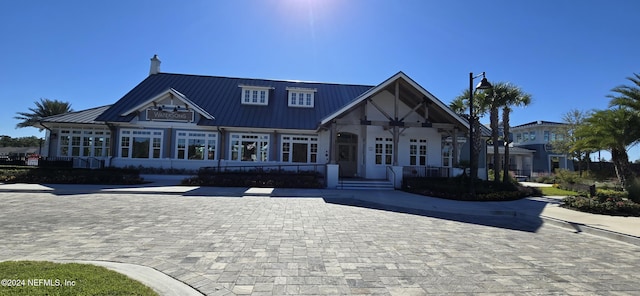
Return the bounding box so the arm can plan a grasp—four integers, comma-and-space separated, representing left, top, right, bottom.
41, 56, 486, 187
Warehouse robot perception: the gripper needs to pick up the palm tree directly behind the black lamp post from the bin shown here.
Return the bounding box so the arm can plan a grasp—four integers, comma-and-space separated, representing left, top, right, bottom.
449, 89, 490, 177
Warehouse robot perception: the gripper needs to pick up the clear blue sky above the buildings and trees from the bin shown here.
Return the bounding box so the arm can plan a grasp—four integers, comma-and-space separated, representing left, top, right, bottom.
0, 0, 640, 160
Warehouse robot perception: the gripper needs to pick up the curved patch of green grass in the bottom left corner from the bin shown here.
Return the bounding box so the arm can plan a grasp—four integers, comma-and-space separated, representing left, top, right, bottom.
0, 261, 158, 296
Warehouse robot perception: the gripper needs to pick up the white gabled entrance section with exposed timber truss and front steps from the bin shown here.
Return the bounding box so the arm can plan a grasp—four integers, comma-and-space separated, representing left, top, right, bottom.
318, 72, 472, 188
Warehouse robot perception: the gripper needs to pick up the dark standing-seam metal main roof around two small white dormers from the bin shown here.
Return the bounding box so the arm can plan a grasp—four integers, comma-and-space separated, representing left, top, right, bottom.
96, 73, 373, 130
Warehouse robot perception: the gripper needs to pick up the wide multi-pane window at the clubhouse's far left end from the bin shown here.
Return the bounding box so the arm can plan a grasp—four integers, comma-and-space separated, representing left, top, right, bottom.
58, 129, 111, 157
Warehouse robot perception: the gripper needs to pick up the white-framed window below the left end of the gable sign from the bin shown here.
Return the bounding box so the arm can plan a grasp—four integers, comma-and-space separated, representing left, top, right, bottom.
120, 130, 163, 158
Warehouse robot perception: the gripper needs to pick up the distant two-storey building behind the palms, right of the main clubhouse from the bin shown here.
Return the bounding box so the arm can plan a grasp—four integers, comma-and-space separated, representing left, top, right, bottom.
487, 121, 573, 177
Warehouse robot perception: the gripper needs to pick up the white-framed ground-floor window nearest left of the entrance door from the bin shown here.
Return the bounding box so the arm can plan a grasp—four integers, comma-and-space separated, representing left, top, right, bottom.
280, 135, 318, 163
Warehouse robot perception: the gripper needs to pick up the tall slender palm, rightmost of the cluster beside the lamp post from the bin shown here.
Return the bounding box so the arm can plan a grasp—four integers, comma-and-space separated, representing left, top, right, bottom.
497, 83, 531, 183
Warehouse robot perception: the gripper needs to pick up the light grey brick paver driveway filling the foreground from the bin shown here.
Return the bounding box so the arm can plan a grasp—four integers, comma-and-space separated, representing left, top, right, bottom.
0, 193, 640, 295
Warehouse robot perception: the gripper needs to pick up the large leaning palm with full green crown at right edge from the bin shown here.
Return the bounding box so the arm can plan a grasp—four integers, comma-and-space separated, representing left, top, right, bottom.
573, 107, 640, 188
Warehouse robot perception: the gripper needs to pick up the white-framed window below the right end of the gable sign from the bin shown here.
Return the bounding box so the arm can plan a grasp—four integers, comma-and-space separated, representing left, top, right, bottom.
175, 131, 218, 160
